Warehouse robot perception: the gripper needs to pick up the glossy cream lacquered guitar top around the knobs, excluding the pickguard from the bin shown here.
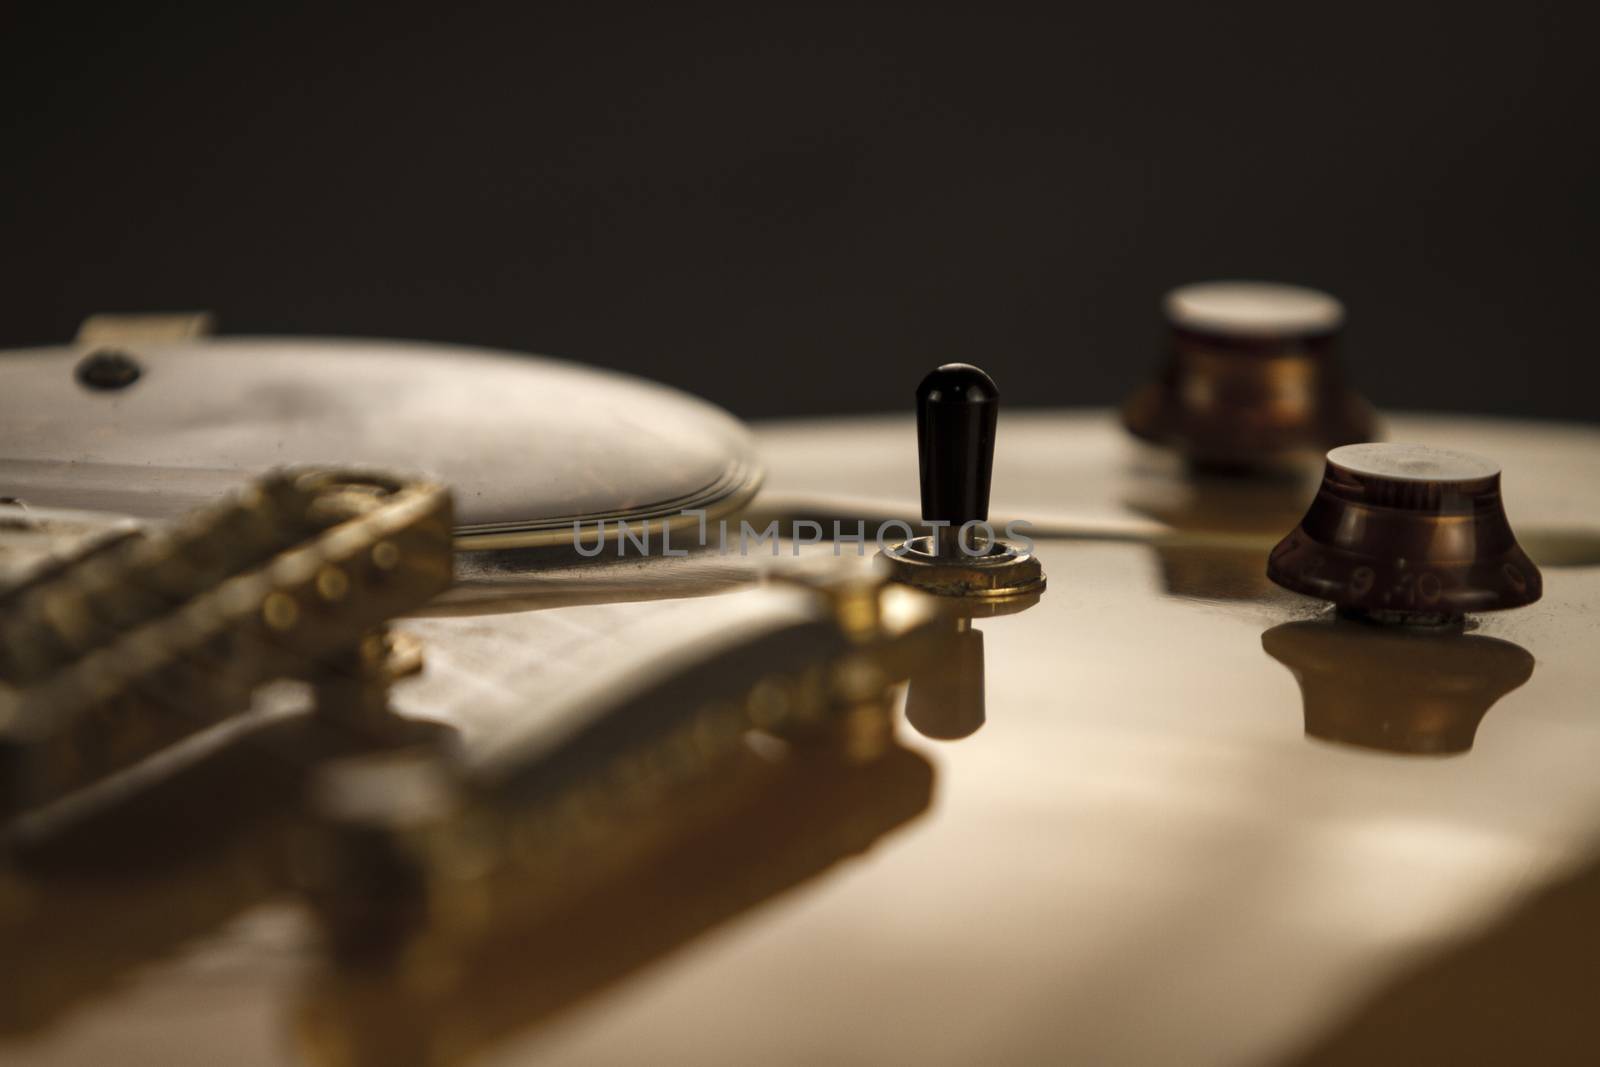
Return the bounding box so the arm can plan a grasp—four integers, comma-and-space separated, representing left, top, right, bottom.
9, 413, 1600, 1065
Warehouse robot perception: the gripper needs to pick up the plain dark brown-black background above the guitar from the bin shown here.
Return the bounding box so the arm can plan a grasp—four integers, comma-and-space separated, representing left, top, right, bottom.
0, 8, 1600, 419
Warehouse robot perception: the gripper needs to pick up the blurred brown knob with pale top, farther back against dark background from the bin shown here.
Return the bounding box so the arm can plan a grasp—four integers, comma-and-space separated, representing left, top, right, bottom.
1122, 282, 1376, 467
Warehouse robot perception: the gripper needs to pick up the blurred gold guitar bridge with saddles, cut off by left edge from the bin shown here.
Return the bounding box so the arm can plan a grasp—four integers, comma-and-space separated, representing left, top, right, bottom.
0, 469, 451, 813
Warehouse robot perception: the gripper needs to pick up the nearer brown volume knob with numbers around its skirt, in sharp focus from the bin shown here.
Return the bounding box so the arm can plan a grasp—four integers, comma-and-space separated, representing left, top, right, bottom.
1267, 445, 1544, 622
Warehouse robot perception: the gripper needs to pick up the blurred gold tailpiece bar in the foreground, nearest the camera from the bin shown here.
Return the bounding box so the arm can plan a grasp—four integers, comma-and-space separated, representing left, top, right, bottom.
300, 574, 947, 955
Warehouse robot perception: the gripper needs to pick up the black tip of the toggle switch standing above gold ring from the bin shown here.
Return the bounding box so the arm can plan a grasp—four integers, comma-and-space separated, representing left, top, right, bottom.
917, 363, 1000, 555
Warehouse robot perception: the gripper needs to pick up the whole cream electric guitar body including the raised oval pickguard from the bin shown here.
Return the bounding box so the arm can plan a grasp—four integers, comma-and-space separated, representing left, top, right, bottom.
0, 326, 1600, 1067
